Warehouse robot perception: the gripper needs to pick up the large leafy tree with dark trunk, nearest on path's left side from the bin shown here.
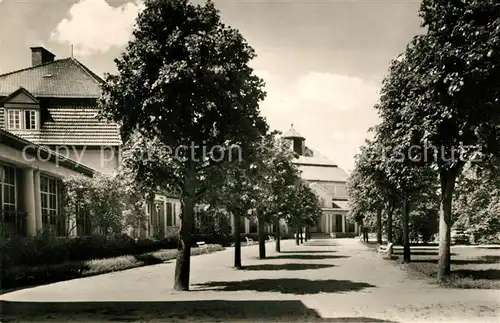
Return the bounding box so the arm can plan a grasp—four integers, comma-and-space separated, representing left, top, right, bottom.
101, 0, 267, 290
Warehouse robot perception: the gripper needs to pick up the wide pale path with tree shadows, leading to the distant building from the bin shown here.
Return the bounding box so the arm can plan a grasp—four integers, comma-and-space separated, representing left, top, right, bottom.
1, 239, 500, 323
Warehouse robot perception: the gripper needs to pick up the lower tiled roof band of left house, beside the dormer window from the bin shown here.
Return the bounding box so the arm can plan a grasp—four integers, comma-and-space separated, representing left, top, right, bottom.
11, 106, 122, 146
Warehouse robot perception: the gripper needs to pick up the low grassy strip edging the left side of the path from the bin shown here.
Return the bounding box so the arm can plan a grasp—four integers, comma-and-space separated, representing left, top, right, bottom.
2, 245, 224, 293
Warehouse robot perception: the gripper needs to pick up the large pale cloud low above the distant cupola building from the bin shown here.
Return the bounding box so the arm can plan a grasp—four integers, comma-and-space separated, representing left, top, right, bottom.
256, 70, 380, 169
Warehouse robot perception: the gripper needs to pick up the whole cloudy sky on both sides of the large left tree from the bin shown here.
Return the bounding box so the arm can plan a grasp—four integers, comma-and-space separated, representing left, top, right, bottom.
0, 0, 421, 170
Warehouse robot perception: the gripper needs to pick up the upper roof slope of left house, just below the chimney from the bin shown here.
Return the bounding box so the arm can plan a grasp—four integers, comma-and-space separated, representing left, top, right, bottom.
0, 57, 103, 98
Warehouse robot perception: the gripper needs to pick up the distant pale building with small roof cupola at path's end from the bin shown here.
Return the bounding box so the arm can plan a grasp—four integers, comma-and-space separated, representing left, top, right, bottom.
283, 125, 357, 235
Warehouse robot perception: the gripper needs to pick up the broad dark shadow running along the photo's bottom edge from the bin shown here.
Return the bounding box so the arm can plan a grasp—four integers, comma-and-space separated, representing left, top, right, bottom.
0, 300, 391, 323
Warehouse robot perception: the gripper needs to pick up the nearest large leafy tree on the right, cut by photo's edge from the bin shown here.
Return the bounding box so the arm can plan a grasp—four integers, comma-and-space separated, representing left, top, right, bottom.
376, 0, 500, 280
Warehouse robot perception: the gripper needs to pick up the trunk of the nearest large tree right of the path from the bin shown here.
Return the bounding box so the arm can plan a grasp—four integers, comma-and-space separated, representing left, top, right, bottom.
437, 169, 458, 282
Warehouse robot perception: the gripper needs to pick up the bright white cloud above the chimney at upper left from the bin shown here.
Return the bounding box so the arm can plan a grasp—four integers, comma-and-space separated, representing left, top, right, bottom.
51, 0, 143, 55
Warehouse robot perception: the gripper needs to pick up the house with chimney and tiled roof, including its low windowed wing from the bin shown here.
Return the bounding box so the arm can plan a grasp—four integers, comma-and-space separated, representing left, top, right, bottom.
0, 47, 180, 237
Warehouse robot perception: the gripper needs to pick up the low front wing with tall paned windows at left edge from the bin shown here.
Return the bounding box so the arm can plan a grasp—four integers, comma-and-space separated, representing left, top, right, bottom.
0, 130, 95, 237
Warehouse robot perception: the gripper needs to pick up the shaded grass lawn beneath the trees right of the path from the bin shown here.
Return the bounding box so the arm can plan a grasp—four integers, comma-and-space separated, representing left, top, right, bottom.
364, 242, 500, 289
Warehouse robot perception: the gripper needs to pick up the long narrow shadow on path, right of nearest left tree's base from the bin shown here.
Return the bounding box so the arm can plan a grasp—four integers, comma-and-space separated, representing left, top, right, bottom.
196, 278, 376, 295
